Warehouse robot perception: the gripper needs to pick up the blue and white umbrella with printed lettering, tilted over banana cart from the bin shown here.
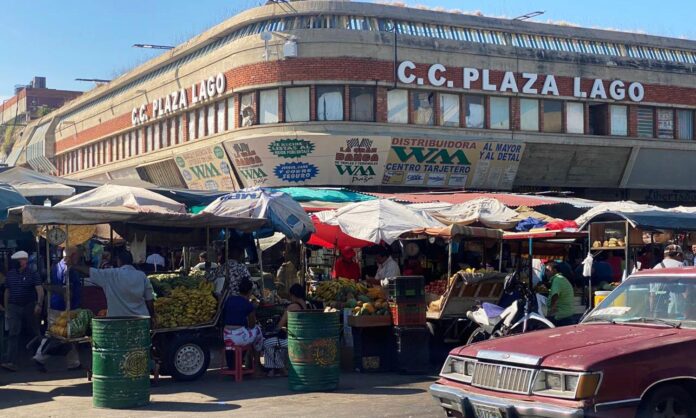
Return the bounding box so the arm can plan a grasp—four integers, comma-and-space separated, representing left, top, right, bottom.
201, 187, 314, 240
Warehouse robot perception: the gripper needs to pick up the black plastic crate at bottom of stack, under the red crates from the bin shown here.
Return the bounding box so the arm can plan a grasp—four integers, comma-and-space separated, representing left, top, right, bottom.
394, 326, 433, 374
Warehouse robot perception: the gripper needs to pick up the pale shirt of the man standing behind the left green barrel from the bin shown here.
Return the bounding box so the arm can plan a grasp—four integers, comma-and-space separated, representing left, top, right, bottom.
89, 266, 154, 316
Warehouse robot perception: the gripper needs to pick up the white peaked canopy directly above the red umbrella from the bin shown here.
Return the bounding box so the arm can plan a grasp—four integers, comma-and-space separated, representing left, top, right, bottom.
316, 199, 444, 244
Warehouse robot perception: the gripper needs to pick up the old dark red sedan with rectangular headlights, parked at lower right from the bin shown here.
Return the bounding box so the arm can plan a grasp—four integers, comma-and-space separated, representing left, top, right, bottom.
430, 268, 696, 418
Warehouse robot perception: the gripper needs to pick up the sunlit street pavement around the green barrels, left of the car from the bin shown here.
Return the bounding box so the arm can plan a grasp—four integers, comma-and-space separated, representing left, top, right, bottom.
0, 367, 444, 418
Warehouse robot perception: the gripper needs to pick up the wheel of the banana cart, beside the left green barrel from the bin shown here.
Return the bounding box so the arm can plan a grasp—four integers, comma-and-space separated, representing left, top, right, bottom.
166, 337, 210, 382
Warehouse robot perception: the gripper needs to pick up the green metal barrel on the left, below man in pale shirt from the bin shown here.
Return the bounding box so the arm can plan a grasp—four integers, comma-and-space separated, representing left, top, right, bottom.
92, 316, 150, 409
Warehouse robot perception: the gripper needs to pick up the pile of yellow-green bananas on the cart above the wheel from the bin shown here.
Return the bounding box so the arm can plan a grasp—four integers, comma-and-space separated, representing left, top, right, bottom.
150, 274, 218, 328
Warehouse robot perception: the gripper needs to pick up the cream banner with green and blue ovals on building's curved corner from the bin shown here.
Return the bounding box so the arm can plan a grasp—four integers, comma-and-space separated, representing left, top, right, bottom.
225, 135, 390, 187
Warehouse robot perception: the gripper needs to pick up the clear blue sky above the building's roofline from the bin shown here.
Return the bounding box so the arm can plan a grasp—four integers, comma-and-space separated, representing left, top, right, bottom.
0, 0, 696, 100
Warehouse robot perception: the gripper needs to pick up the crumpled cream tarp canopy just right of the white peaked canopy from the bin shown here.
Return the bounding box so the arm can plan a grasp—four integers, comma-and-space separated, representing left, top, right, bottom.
429, 197, 520, 229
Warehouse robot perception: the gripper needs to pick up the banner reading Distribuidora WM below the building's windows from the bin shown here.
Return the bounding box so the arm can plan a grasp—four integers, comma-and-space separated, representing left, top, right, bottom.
382, 138, 524, 190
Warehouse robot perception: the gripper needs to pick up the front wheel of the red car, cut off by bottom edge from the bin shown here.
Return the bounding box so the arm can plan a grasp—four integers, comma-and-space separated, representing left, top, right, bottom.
637, 385, 696, 418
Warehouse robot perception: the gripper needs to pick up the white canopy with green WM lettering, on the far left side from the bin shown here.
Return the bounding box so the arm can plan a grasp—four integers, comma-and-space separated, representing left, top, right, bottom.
56, 184, 186, 213
